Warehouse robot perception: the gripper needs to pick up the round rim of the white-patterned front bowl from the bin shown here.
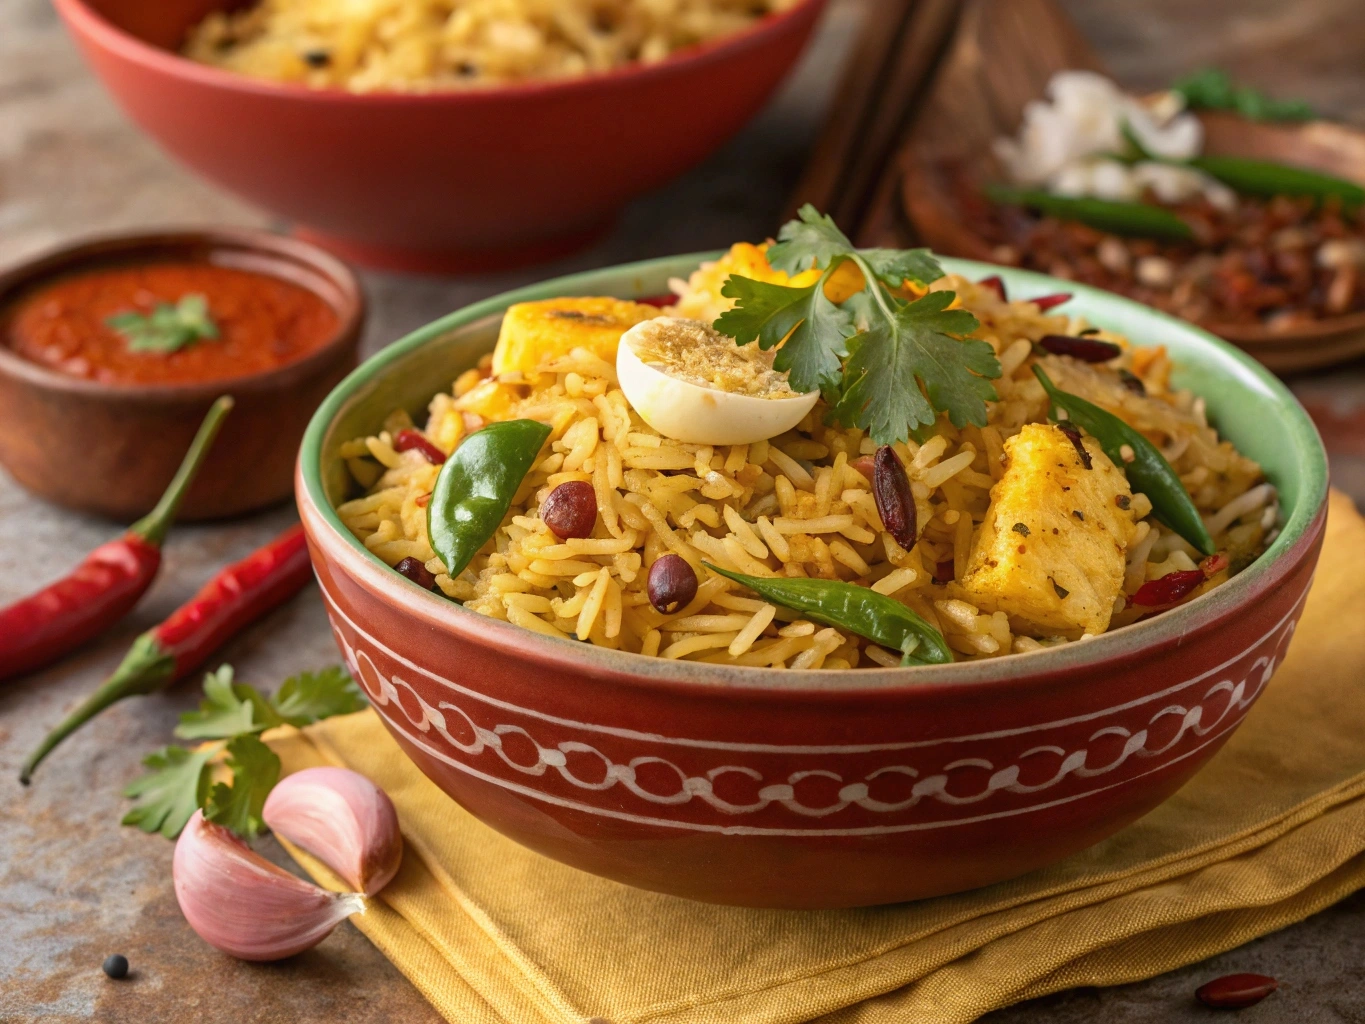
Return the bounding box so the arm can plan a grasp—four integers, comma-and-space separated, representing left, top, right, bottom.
296, 253, 1327, 695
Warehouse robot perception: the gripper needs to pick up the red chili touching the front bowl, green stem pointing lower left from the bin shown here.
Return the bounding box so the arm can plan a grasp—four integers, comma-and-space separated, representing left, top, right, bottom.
19, 526, 313, 785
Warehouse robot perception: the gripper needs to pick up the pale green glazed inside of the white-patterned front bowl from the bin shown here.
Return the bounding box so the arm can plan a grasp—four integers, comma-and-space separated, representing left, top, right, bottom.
300, 253, 1327, 688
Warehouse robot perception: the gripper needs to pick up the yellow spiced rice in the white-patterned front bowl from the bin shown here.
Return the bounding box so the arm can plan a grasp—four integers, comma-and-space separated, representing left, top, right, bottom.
337, 244, 1279, 669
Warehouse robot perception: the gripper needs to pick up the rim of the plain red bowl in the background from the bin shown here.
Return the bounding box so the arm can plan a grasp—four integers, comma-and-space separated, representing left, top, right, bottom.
53, 0, 827, 106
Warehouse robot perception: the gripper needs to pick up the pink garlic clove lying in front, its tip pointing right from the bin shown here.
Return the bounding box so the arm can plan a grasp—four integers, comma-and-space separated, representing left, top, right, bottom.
172, 811, 364, 960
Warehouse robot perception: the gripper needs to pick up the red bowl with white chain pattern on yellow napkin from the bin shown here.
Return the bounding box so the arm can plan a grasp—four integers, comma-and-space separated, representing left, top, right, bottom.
298, 257, 1327, 907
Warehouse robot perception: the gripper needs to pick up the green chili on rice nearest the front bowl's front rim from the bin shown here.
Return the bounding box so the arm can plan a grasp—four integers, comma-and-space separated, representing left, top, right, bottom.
702, 563, 953, 665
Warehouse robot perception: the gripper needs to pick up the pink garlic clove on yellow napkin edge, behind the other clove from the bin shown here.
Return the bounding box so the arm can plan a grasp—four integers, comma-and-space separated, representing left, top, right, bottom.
262, 767, 403, 896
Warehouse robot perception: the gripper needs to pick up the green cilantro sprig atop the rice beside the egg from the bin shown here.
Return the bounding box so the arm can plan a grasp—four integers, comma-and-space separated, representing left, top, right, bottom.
714, 203, 1001, 445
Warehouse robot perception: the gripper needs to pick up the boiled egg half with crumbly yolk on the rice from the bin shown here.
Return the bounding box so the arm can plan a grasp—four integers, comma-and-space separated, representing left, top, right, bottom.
616, 317, 820, 445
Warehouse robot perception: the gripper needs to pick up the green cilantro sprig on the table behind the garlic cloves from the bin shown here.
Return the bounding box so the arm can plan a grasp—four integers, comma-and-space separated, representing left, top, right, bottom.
123, 665, 366, 838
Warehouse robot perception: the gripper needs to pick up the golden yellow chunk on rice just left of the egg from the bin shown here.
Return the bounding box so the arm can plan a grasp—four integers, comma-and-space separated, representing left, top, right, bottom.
493, 296, 659, 375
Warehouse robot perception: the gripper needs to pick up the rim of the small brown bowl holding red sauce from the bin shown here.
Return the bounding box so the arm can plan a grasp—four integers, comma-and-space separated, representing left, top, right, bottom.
0, 228, 366, 406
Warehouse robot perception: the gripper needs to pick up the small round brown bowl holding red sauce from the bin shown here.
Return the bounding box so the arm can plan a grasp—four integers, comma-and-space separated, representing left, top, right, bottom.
0, 229, 364, 520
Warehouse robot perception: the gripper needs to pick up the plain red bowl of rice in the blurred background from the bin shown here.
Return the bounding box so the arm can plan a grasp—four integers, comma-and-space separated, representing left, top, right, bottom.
56, 0, 824, 270
